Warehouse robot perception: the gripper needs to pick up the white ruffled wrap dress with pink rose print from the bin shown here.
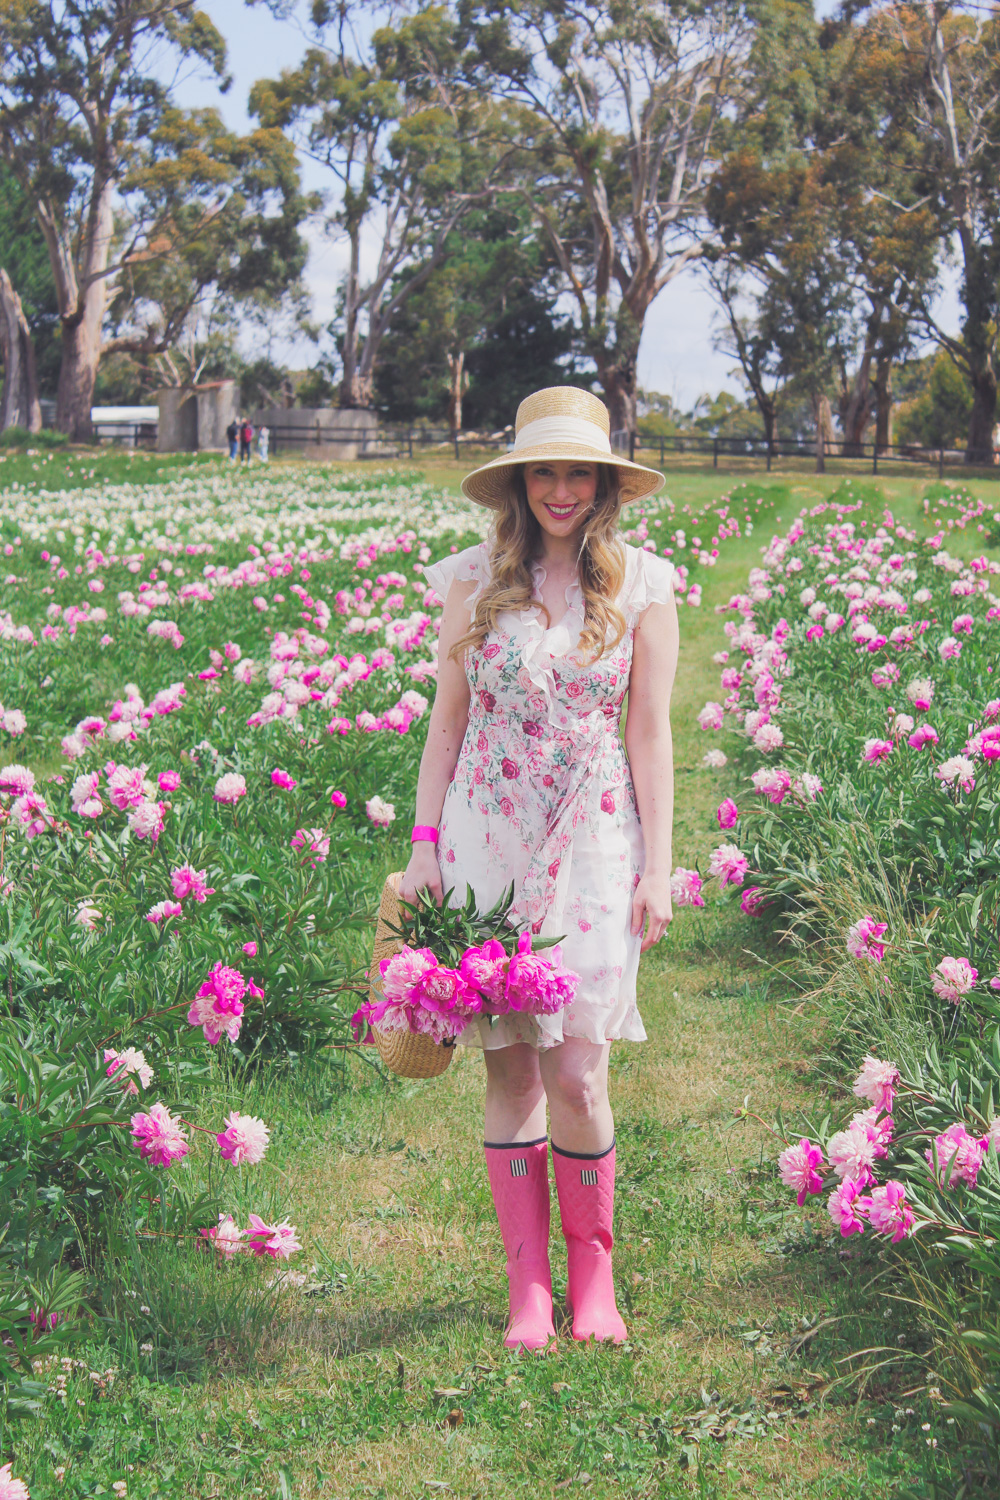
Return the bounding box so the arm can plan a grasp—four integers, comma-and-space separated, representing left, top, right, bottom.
424, 543, 673, 1049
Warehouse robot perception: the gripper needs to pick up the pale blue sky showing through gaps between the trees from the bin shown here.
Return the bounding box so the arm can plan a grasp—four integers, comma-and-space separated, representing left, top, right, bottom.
177, 0, 960, 410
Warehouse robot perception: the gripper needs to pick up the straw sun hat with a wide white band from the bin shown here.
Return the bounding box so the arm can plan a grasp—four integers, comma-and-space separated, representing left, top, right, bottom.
462, 386, 666, 510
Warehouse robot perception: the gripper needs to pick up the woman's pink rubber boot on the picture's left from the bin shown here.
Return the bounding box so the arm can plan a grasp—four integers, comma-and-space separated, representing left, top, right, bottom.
486, 1136, 556, 1349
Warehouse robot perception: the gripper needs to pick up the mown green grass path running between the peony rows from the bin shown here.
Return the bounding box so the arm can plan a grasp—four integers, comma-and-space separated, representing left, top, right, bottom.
0, 471, 973, 1500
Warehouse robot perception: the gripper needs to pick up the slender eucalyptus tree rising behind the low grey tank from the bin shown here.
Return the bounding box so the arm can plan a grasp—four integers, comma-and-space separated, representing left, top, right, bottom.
250, 0, 500, 408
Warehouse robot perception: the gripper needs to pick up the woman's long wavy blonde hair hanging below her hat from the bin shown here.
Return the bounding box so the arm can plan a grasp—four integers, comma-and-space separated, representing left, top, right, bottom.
451, 464, 625, 662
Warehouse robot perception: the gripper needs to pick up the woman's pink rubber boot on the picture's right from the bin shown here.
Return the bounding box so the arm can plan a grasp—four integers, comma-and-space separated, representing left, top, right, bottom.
552, 1142, 628, 1344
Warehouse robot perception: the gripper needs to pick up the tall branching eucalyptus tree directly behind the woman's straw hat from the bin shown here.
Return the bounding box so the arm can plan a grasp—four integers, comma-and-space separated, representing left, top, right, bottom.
457, 0, 766, 431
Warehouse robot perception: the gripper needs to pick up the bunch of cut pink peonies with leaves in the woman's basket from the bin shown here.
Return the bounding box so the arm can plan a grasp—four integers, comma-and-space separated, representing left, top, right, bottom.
354, 887, 580, 1043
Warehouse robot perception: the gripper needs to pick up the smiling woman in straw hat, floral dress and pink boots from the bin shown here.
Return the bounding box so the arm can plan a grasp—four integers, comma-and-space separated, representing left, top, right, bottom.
400, 387, 678, 1349
